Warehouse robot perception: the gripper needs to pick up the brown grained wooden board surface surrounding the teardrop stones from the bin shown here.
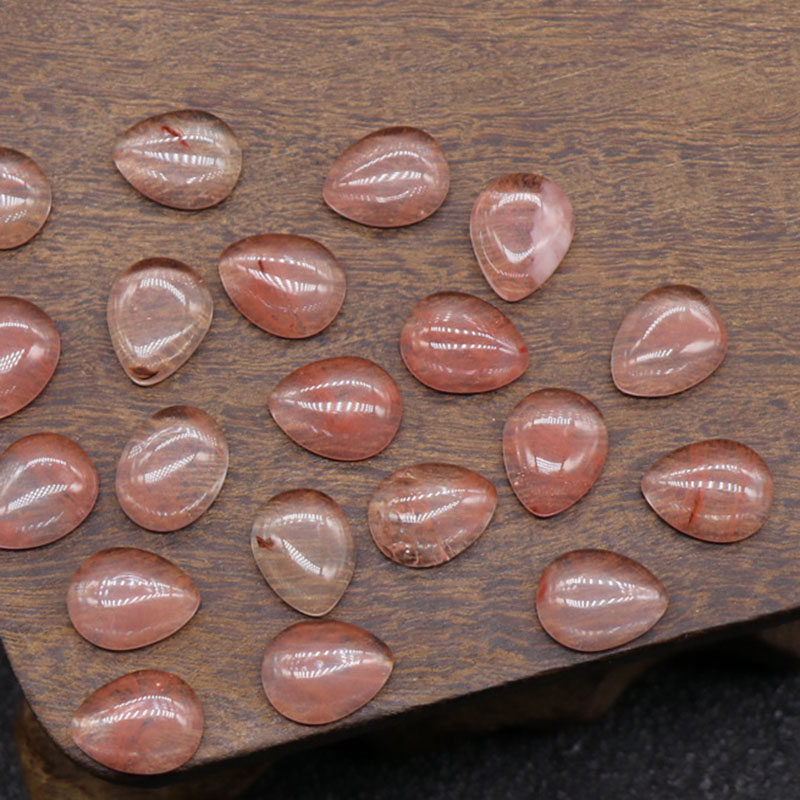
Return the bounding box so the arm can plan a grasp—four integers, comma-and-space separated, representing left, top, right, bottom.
0, 0, 800, 780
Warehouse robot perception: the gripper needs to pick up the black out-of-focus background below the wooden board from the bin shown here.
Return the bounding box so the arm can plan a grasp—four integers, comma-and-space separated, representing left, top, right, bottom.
0, 652, 800, 800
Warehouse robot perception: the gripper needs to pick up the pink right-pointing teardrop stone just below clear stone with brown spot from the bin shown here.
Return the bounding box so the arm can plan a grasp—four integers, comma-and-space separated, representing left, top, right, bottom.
261, 620, 394, 725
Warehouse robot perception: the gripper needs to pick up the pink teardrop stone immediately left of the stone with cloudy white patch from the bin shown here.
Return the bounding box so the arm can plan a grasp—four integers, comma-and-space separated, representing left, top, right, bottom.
322, 127, 450, 228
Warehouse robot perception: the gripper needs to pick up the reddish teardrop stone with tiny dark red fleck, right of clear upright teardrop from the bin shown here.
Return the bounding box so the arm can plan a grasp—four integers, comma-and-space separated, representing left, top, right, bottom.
219, 233, 347, 339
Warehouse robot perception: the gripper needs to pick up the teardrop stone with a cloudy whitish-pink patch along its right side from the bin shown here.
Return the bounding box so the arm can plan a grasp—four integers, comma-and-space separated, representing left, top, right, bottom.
469, 173, 575, 302
